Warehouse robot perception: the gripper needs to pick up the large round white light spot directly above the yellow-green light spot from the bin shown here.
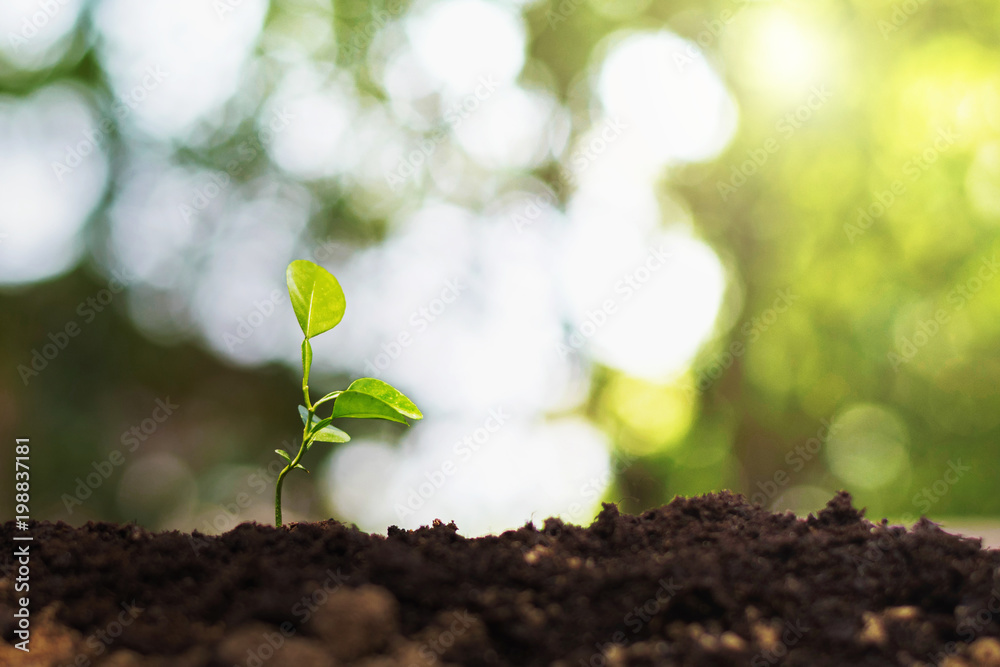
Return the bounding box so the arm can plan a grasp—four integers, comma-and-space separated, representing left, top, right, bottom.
560, 206, 726, 381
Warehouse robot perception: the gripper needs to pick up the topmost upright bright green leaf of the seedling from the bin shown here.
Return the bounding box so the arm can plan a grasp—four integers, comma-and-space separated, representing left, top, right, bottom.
285, 259, 347, 339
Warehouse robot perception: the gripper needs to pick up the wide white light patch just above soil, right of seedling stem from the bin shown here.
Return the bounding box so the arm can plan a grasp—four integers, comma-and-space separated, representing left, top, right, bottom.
323, 418, 612, 537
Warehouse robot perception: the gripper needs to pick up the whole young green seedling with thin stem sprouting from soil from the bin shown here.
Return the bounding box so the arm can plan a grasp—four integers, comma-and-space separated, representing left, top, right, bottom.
274, 259, 423, 526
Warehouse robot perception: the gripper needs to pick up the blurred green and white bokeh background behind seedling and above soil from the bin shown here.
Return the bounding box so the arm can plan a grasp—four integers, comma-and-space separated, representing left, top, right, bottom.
0, 0, 1000, 535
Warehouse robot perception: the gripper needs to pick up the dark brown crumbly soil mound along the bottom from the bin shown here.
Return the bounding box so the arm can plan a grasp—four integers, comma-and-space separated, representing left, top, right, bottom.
0, 493, 1000, 667
